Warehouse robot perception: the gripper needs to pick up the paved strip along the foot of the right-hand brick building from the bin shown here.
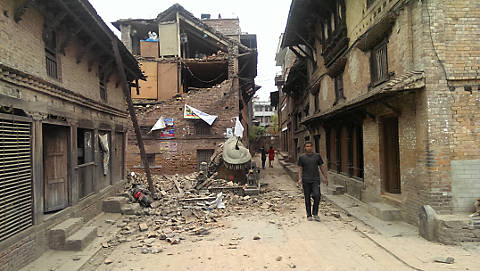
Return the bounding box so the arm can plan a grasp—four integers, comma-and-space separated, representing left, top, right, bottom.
279, 153, 480, 270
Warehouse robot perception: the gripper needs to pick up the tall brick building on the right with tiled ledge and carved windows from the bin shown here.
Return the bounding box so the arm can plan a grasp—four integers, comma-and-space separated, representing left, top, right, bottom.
277, 0, 480, 242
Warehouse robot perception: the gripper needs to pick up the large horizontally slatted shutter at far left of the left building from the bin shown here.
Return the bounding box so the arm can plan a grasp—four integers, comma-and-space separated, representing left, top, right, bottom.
0, 118, 33, 242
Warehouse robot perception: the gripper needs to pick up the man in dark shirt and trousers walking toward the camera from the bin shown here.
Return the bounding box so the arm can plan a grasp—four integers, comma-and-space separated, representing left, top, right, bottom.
298, 142, 328, 221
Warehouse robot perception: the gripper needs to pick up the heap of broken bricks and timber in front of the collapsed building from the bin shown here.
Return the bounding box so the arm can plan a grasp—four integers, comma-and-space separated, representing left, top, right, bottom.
104, 173, 295, 253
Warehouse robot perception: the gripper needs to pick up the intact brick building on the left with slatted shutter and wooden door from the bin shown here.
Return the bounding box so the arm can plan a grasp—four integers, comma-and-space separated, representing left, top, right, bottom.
0, 0, 143, 270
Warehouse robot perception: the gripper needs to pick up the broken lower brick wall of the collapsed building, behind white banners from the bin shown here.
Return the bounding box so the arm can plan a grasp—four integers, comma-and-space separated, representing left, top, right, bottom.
127, 79, 239, 174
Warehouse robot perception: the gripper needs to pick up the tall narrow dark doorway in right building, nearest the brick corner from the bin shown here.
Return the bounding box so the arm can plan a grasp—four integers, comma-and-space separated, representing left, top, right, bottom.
383, 118, 401, 194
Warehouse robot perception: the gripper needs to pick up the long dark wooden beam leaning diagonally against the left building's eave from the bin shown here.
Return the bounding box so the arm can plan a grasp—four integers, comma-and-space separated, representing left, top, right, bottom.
112, 39, 155, 194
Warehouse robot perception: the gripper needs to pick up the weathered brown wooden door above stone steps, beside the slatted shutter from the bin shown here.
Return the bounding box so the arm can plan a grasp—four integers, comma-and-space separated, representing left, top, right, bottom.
43, 125, 68, 212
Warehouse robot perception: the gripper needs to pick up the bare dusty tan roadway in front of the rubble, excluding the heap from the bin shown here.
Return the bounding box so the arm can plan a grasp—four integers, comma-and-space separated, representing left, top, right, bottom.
70, 157, 473, 270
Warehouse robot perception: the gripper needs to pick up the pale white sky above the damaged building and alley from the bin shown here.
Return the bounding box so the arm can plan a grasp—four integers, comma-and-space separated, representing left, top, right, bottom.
90, 0, 291, 100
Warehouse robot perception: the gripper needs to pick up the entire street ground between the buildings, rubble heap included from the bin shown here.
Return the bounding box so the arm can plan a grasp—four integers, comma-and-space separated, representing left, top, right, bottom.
81, 159, 478, 271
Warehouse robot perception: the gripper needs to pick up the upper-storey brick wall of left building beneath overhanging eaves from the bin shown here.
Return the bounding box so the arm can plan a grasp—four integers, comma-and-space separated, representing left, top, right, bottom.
0, 0, 126, 110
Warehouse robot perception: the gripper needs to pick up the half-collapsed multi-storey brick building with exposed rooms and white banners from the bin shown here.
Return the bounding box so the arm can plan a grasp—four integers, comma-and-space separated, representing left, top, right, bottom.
113, 4, 259, 174
